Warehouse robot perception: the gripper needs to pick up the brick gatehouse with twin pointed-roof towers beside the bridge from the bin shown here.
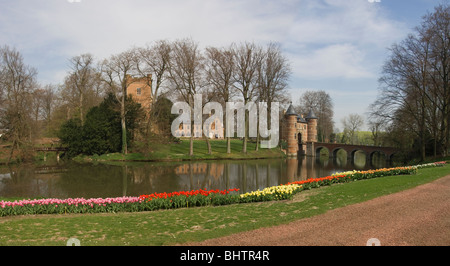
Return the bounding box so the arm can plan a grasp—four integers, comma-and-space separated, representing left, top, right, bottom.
280, 103, 317, 156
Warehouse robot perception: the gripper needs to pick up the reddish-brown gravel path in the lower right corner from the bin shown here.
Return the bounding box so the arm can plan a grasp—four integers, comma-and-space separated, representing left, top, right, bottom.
191, 175, 450, 246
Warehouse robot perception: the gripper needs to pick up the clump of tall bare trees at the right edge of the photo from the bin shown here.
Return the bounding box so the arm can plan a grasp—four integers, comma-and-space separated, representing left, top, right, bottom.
371, 4, 450, 160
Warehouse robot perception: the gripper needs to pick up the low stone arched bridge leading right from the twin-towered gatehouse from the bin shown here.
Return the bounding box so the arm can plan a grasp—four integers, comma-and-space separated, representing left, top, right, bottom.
310, 142, 399, 162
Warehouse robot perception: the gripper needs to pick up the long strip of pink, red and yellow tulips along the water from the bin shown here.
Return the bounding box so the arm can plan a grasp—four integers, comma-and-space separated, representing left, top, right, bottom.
0, 162, 446, 217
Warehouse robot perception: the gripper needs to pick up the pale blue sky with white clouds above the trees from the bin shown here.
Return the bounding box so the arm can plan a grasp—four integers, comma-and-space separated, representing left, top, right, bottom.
0, 0, 442, 130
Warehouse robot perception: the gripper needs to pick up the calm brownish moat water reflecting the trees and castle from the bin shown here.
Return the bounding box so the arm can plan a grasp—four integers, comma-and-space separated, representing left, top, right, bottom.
0, 154, 386, 198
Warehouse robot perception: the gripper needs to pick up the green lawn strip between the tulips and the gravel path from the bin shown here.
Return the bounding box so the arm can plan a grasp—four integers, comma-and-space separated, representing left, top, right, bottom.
0, 165, 450, 246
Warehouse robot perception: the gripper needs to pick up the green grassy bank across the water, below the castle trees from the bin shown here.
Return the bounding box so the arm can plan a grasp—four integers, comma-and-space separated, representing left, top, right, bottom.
75, 139, 285, 162
